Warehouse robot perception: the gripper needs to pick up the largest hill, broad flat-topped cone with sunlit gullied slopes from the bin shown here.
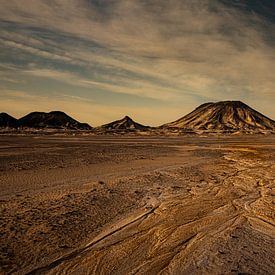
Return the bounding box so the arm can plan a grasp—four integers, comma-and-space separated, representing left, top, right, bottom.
162, 101, 275, 131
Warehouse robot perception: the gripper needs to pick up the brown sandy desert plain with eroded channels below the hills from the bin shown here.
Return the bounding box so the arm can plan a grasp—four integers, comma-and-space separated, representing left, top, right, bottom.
0, 136, 275, 274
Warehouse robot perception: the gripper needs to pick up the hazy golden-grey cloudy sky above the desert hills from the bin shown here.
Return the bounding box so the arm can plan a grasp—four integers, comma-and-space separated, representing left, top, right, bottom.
0, 0, 275, 126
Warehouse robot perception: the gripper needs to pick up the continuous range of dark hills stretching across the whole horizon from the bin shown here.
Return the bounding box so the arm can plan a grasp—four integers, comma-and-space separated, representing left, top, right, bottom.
0, 101, 275, 134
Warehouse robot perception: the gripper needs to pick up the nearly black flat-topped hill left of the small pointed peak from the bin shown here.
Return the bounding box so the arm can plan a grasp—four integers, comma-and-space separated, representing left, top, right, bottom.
18, 111, 92, 130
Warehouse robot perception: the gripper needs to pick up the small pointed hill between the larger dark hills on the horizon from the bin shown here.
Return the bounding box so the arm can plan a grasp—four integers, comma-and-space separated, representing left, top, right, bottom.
99, 116, 150, 131
